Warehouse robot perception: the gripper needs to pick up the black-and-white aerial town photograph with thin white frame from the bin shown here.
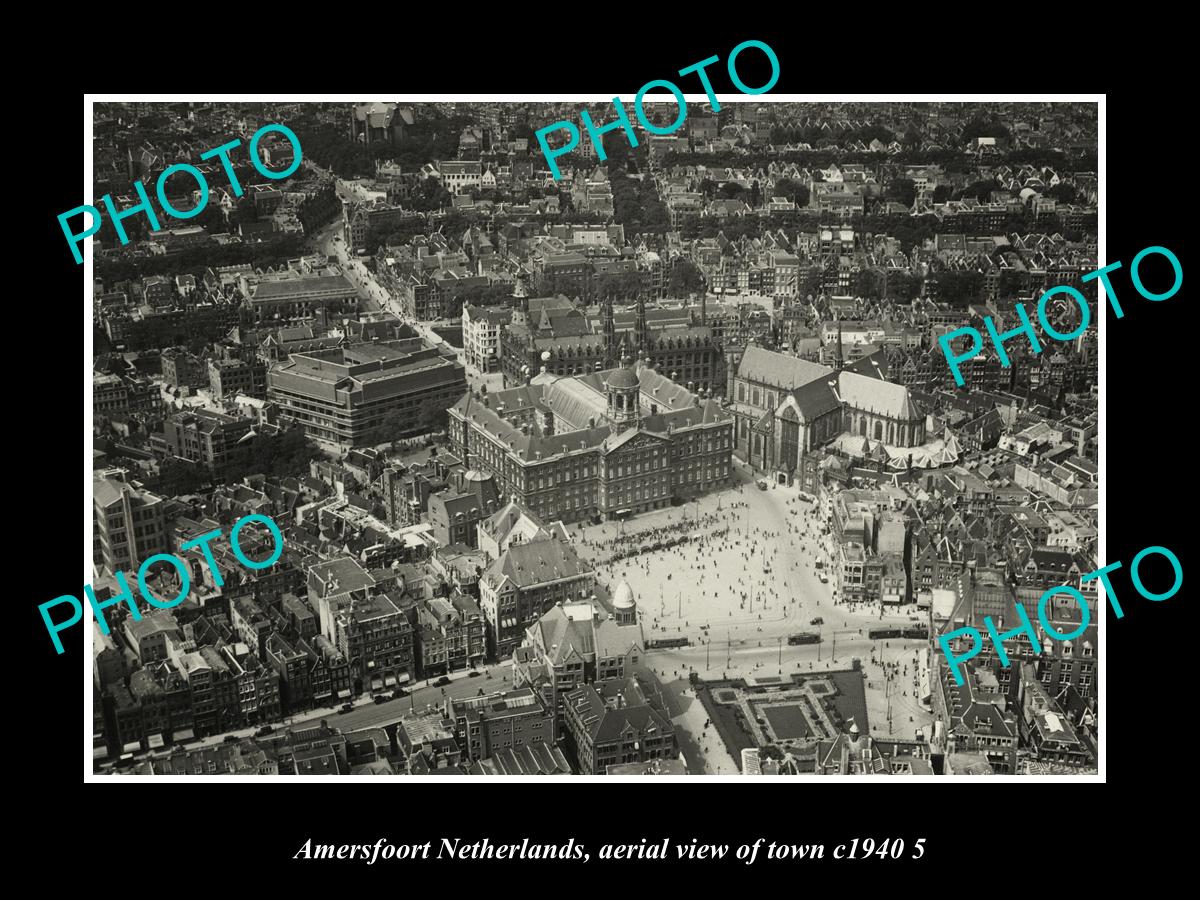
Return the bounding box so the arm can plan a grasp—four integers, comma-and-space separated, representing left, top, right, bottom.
72, 93, 1104, 781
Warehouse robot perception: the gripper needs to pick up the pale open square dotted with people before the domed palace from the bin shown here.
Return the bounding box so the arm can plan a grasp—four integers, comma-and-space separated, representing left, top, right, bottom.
572, 464, 932, 774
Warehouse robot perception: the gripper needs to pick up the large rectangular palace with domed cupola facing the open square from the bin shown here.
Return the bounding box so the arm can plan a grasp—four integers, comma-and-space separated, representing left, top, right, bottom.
450, 356, 733, 522
